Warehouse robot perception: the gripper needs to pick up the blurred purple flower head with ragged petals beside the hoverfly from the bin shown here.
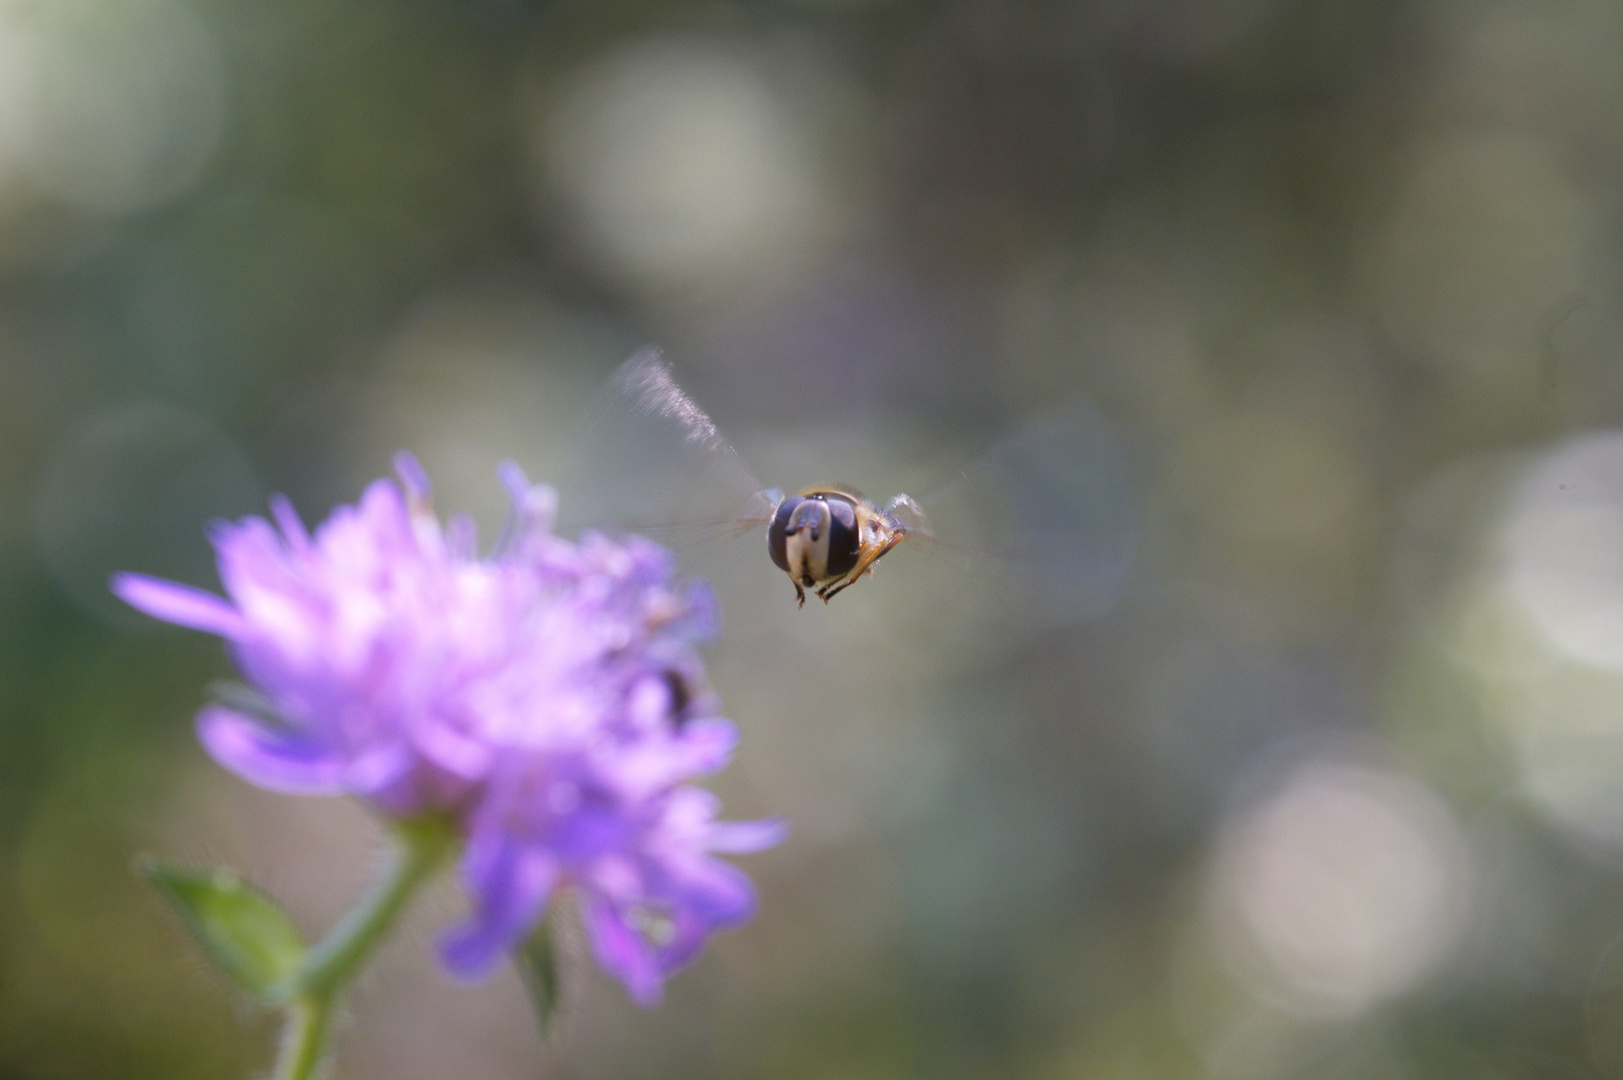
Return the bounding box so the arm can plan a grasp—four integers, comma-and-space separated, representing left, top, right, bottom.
112, 453, 784, 1004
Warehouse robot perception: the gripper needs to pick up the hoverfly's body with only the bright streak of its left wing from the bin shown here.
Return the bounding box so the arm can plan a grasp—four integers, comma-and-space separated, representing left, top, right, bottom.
612, 348, 930, 607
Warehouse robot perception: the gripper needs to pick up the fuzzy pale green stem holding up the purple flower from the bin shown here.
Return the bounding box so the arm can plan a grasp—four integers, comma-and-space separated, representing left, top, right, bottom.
271, 819, 456, 1080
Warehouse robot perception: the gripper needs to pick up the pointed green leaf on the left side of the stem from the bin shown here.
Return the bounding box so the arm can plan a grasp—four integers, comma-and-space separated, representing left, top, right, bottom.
138, 862, 307, 1004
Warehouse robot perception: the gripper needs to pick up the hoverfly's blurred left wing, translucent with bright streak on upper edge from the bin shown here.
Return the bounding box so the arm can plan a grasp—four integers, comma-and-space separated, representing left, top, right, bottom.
558, 348, 776, 546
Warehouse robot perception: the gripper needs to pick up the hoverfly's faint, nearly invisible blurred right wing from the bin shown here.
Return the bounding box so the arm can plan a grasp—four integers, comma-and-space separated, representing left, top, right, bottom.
898, 401, 1138, 627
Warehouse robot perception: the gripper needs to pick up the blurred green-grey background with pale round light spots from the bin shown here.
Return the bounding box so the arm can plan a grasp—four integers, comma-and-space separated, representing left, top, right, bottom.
0, 0, 1623, 1080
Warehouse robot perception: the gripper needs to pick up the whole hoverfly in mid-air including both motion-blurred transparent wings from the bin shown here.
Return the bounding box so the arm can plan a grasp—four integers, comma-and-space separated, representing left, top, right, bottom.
563, 348, 1133, 620
